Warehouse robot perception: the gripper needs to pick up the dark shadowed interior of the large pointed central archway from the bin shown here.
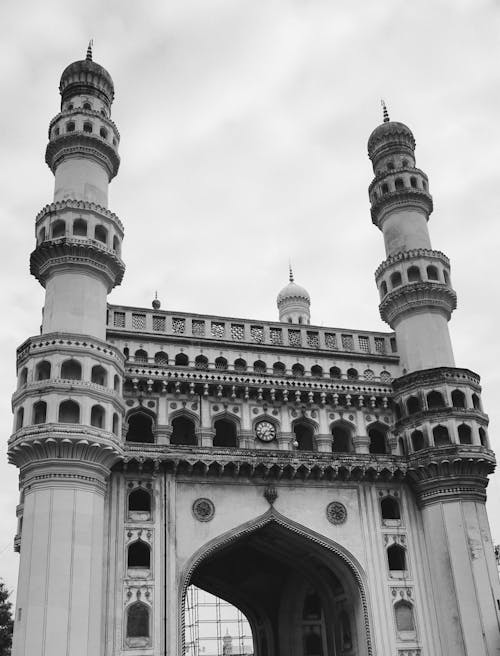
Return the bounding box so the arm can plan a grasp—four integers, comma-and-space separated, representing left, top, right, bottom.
180, 508, 372, 656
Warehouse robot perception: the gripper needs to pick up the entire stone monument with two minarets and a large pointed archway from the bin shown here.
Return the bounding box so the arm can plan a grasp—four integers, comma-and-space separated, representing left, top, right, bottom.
9, 51, 500, 656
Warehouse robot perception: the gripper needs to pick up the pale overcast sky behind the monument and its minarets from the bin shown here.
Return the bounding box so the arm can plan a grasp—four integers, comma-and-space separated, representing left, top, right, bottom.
0, 0, 500, 589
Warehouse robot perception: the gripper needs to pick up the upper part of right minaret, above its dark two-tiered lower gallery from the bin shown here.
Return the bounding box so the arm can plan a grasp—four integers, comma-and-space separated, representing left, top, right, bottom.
368, 105, 456, 372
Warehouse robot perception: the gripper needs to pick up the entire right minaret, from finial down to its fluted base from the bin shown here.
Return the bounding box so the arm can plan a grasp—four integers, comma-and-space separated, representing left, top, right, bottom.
368, 106, 500, 656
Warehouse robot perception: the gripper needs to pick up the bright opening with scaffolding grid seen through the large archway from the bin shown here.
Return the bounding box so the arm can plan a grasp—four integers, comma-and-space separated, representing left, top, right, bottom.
184, 585, 253, 656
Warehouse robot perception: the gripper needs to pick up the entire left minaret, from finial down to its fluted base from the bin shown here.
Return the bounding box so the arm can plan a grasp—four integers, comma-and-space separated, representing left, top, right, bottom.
9, 47, 125, 656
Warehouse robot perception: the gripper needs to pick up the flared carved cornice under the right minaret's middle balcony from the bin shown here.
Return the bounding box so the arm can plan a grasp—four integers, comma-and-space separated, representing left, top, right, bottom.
379, 281, 457, 327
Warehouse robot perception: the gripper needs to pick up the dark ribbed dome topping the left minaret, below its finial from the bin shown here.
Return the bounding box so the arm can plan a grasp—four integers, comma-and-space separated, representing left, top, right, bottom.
59, 58, 115, 105
